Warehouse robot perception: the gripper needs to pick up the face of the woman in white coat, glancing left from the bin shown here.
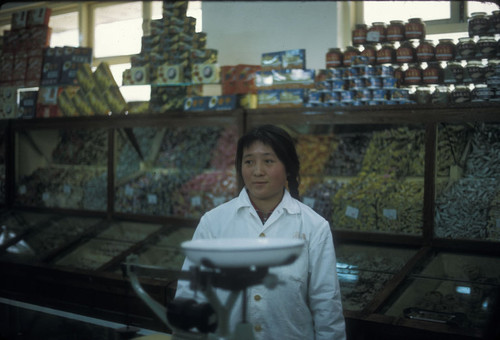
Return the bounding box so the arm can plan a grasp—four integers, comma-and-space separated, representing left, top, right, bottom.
241, 141, 286, 209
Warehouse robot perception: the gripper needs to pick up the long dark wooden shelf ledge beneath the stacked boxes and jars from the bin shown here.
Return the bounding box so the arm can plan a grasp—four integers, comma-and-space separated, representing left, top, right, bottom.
12, 102, 500, 128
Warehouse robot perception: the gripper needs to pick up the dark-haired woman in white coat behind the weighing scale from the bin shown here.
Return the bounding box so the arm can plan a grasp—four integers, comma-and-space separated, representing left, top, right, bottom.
176, 125, 345, 340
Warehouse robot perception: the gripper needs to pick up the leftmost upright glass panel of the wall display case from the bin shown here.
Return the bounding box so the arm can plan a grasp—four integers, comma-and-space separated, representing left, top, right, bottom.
14, 128, 108, 211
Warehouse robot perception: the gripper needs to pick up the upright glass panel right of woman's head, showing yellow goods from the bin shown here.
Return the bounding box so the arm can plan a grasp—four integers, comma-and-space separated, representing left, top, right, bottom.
256, 123, 425, 235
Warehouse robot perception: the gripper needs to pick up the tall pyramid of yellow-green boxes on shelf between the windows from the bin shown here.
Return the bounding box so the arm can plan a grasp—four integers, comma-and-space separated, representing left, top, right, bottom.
123, 1, 220, 113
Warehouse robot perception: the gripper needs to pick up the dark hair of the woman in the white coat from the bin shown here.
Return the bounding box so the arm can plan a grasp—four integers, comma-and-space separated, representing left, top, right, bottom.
235, 125, 300, 199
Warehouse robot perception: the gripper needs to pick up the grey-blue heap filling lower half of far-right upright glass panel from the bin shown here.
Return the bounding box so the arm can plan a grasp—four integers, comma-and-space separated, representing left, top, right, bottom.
435, 178, 500, 239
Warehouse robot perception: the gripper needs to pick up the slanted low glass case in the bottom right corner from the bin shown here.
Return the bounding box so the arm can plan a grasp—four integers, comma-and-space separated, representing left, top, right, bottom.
383, 252, 500, 330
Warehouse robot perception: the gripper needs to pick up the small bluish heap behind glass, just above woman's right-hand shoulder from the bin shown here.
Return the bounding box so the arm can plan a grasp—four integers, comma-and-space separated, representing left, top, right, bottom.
301, 179, 342, 222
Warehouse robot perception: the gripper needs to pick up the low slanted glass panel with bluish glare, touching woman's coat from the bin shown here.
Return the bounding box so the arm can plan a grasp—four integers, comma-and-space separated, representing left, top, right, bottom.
336, 244, 416, 311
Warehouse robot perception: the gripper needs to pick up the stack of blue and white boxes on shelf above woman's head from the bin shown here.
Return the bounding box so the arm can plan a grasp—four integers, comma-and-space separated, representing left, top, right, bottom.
256, 49, 315, 108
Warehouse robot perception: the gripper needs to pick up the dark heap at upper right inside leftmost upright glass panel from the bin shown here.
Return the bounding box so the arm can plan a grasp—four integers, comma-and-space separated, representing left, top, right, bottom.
52, 129, 108, 166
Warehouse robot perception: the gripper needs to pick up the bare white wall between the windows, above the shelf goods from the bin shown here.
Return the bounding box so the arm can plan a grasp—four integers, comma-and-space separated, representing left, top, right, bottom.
202, 1, 338, 70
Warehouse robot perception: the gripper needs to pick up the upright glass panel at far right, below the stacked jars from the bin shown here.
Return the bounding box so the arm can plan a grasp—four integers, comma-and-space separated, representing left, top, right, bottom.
434, 123, 500, 241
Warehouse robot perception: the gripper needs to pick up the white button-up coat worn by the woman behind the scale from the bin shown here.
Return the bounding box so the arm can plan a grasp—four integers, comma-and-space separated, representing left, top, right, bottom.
176, 189, 346, 340
